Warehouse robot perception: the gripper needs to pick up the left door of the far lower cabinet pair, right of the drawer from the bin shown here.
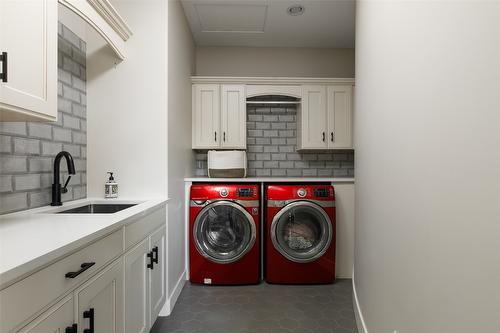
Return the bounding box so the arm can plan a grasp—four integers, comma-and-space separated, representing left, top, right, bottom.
125, 238, 152, 333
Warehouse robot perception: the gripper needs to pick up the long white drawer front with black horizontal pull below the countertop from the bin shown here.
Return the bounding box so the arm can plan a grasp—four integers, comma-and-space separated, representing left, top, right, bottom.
0, 229, 123, 333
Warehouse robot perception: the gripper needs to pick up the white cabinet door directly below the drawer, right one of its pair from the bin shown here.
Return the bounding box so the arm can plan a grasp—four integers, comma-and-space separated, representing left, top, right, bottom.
74, 259, 123, 333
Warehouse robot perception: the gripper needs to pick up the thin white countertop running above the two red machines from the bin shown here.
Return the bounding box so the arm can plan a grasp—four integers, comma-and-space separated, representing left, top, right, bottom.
184, 177, 354, 183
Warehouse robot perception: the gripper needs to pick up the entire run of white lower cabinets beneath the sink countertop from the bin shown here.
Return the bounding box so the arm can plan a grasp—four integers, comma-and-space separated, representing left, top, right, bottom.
0, 206, 166, 333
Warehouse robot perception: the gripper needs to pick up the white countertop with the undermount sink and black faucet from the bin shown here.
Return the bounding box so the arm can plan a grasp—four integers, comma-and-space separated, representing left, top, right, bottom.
0, 198, 167, 289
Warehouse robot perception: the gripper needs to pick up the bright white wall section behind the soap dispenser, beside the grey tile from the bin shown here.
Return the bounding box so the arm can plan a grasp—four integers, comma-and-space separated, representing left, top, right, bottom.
87, 0, 168, 198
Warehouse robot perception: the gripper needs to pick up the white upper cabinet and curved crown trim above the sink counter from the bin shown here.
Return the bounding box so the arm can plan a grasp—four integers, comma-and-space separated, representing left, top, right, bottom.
0, 0, 132, 121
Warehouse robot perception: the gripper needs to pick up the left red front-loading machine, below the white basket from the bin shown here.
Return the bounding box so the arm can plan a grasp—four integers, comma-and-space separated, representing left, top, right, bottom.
189, 184, 260, 285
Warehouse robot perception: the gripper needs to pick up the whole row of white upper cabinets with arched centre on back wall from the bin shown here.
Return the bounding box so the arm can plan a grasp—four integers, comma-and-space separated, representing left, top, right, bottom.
191, 76, 354, 150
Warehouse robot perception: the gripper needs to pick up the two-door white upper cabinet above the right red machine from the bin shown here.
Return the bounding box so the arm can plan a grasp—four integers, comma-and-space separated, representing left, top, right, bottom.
297, 85, 353, 150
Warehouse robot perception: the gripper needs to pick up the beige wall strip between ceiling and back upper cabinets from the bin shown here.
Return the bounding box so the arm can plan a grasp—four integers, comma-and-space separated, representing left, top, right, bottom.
196, 47, 354, 77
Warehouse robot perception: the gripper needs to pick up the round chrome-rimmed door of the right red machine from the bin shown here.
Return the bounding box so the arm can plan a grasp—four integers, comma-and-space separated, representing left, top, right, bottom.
271, 201, 332, 263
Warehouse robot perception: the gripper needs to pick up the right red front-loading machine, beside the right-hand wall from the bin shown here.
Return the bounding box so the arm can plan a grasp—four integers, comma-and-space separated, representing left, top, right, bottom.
265, 185, 335, 284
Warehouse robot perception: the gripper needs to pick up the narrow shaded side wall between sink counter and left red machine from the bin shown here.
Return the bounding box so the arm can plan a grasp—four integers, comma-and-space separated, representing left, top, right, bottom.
168, 1, 195, 306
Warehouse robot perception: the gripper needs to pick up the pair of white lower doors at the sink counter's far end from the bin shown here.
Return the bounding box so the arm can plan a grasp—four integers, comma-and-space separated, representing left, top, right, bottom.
124, 227, 166, 333
